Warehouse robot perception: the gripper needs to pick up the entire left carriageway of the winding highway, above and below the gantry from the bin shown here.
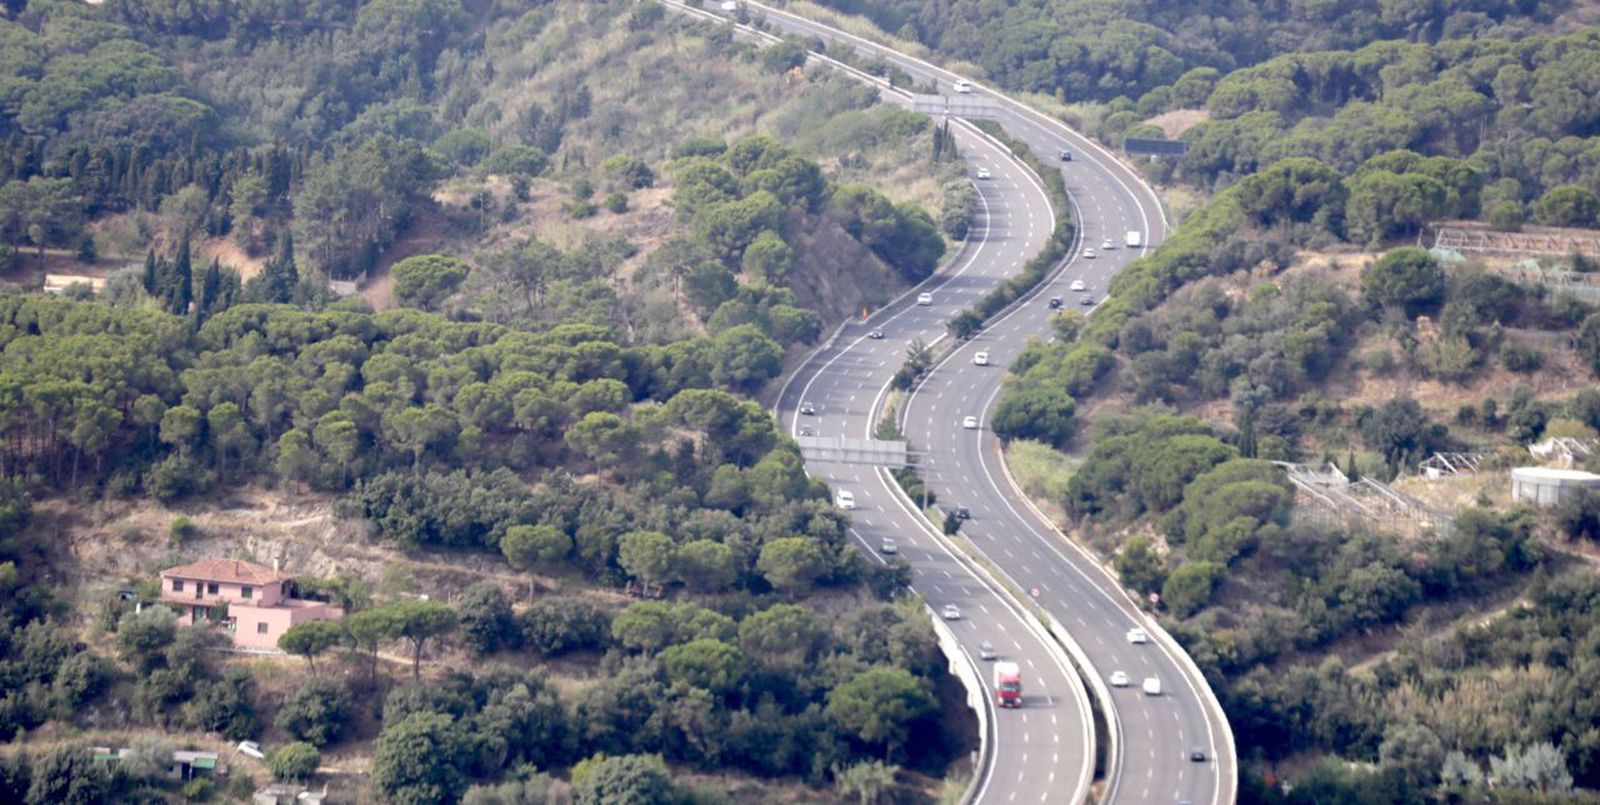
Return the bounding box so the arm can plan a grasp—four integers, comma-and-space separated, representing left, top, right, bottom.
669, 3, 1096, 803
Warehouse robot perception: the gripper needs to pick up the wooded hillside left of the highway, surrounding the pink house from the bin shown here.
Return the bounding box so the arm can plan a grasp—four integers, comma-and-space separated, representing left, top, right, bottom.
0, 0, 970, 803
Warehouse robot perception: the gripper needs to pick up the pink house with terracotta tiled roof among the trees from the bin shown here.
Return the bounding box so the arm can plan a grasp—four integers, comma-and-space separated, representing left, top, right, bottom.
162, 559, 344, 648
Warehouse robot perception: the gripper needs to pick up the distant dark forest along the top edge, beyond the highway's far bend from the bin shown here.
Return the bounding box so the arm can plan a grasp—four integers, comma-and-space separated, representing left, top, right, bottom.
822, 0, 1576, 102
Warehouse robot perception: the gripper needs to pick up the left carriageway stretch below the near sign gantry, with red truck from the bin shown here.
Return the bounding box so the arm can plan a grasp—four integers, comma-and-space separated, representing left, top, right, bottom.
814, 463, 1091, 802
